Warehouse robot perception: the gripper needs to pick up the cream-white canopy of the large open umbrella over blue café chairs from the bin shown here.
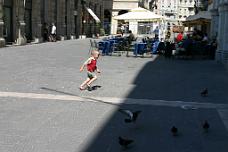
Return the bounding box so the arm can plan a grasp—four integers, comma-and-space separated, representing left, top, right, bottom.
114, 7, 164, 21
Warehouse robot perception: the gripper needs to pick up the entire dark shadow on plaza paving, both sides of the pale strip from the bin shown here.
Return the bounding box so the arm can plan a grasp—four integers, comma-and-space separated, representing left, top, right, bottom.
79, 58, 228, 152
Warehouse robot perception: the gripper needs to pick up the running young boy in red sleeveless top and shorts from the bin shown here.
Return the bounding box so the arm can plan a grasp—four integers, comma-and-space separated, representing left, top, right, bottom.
79, 50, 100, 91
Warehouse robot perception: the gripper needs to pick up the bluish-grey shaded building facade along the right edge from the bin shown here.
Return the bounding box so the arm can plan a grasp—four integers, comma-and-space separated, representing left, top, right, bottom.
211, 0, 228, 66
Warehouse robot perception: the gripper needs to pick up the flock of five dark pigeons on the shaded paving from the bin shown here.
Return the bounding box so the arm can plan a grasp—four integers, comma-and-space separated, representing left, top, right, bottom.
118, 88, 210, 149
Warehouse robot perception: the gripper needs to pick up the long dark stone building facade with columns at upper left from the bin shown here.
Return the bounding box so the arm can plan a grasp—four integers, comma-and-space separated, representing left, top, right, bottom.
0, 0, 104, 46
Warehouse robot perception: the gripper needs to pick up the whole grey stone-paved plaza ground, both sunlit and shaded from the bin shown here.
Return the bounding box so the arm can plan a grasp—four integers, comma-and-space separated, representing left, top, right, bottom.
0, 39, 228, 152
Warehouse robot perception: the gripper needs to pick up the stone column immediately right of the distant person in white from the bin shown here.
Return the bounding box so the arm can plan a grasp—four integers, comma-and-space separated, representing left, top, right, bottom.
56, 0, 66, 40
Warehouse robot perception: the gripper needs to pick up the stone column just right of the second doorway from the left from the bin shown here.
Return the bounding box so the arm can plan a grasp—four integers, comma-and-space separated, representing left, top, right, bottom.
32, 0, 42, 42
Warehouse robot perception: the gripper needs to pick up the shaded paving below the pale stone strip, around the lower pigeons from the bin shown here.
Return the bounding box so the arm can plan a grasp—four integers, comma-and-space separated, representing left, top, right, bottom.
82, 105, 228, 152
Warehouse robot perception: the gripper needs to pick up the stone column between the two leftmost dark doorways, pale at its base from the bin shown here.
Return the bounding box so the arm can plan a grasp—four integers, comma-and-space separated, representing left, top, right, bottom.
14, 0, 27, 45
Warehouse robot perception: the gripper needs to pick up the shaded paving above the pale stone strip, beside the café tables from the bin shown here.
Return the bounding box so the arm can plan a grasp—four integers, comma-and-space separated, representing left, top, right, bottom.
128, 58, 228, 103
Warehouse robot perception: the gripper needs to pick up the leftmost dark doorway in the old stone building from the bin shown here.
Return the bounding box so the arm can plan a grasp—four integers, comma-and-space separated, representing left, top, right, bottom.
3, 0, 13, 43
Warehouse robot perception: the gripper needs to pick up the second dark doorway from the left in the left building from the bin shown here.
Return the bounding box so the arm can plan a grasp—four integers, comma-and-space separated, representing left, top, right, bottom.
24, 0, 32, 42
